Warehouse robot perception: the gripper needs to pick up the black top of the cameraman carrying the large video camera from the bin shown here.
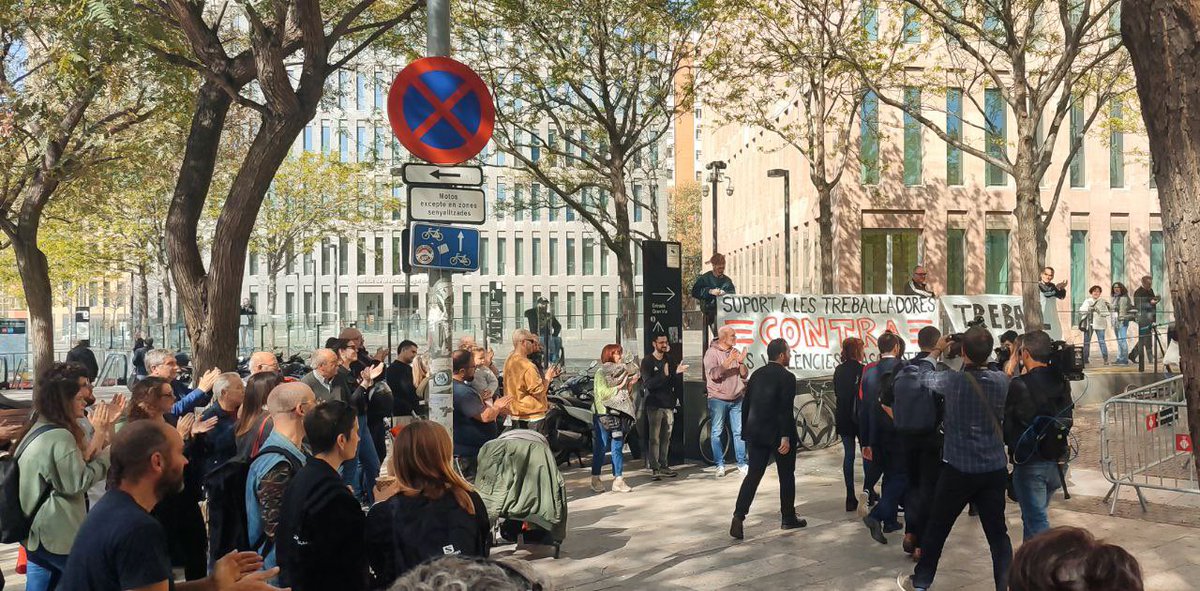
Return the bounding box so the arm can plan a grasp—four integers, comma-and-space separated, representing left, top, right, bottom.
1004, 366, 1074, 464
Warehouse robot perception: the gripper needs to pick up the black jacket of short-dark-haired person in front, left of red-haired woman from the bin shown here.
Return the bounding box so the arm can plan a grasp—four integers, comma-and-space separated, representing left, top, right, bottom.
275, 458, 368, 591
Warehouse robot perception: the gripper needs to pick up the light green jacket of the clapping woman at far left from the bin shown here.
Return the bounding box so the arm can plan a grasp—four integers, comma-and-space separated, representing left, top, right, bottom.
17, 420, 108, 555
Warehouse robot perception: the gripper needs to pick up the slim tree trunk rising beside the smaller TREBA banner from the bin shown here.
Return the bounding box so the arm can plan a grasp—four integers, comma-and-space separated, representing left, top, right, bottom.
1017, 175, 1045, 330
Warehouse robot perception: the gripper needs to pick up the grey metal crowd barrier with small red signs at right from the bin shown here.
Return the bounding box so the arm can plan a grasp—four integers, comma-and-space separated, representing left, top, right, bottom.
1100, 376, 1200, 515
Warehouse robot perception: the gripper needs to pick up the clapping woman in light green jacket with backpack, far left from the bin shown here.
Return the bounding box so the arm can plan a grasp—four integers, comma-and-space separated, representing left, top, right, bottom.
11, 363, 121, 591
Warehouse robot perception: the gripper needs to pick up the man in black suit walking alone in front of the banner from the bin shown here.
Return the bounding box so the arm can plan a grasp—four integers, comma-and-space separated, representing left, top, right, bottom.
730, 339, 808, 539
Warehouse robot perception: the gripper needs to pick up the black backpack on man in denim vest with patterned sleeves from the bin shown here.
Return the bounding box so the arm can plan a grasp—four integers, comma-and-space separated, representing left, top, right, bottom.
204, 446, 304, 561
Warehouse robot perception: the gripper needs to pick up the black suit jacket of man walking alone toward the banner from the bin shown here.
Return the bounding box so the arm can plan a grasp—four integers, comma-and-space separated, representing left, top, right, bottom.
742, 363, 800, 447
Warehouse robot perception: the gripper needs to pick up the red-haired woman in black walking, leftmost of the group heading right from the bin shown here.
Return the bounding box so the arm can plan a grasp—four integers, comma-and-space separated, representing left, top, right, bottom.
858, 333, 907, 544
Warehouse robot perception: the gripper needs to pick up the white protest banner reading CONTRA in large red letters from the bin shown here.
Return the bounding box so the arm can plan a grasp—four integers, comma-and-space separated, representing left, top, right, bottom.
716, 294, 940, 377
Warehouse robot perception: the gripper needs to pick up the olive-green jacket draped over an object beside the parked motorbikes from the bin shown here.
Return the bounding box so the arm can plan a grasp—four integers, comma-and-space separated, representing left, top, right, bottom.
475, 431, 566, 542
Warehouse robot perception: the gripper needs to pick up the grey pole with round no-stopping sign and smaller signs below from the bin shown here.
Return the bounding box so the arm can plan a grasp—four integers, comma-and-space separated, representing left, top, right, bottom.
388, 0, 496, 431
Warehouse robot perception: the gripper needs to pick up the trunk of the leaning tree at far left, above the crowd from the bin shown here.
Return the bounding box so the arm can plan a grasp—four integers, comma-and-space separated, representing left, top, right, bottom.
12, 233, 54, 381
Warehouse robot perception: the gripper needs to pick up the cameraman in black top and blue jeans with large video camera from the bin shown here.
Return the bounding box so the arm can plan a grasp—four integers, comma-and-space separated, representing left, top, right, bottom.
1004, 330, 1074, 541
